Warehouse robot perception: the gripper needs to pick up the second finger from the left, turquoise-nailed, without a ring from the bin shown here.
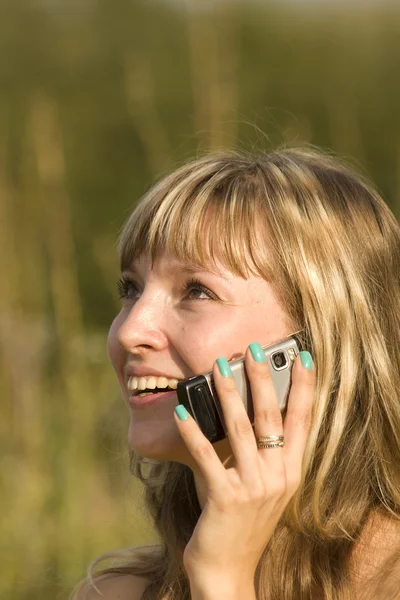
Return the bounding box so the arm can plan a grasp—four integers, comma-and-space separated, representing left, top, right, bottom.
213, 357, 257, 473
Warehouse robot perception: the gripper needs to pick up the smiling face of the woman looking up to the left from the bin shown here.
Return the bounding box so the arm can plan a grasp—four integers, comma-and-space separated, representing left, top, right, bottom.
108, 248, 294, 466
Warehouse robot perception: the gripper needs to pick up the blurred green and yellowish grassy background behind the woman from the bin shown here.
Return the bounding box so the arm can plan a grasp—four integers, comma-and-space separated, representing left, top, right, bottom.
0, 0, 400, 600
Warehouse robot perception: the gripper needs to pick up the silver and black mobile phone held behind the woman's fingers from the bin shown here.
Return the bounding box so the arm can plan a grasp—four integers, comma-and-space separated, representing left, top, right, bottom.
177, 332, 302, 443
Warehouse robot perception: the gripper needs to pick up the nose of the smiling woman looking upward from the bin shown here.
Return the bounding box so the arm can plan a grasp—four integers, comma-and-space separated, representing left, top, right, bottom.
117, 294, 168, 354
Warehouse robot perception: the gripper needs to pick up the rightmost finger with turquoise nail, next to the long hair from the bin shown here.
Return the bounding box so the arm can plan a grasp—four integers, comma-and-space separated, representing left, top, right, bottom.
283, 352, 315, 491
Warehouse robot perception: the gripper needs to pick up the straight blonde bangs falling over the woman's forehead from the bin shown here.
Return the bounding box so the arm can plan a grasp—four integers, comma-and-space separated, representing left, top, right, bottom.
119, 158, 272, 281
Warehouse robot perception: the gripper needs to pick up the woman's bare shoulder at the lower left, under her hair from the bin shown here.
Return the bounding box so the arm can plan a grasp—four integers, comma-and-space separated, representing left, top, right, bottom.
77, 575, 150, 600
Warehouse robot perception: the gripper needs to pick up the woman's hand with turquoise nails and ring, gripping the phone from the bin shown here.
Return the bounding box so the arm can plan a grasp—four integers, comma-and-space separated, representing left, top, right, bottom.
174, 344, 315, 582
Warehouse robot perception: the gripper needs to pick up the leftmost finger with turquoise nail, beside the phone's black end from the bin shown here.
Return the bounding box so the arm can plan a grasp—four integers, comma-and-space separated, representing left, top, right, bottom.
174, 404, 226, 494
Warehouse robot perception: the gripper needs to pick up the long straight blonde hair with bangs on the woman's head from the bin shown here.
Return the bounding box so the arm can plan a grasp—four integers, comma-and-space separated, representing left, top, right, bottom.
70, 149, 400, 600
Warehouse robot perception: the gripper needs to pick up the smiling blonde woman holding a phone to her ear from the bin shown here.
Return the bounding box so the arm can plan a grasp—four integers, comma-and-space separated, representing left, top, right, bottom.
74, 149, 400, 600
